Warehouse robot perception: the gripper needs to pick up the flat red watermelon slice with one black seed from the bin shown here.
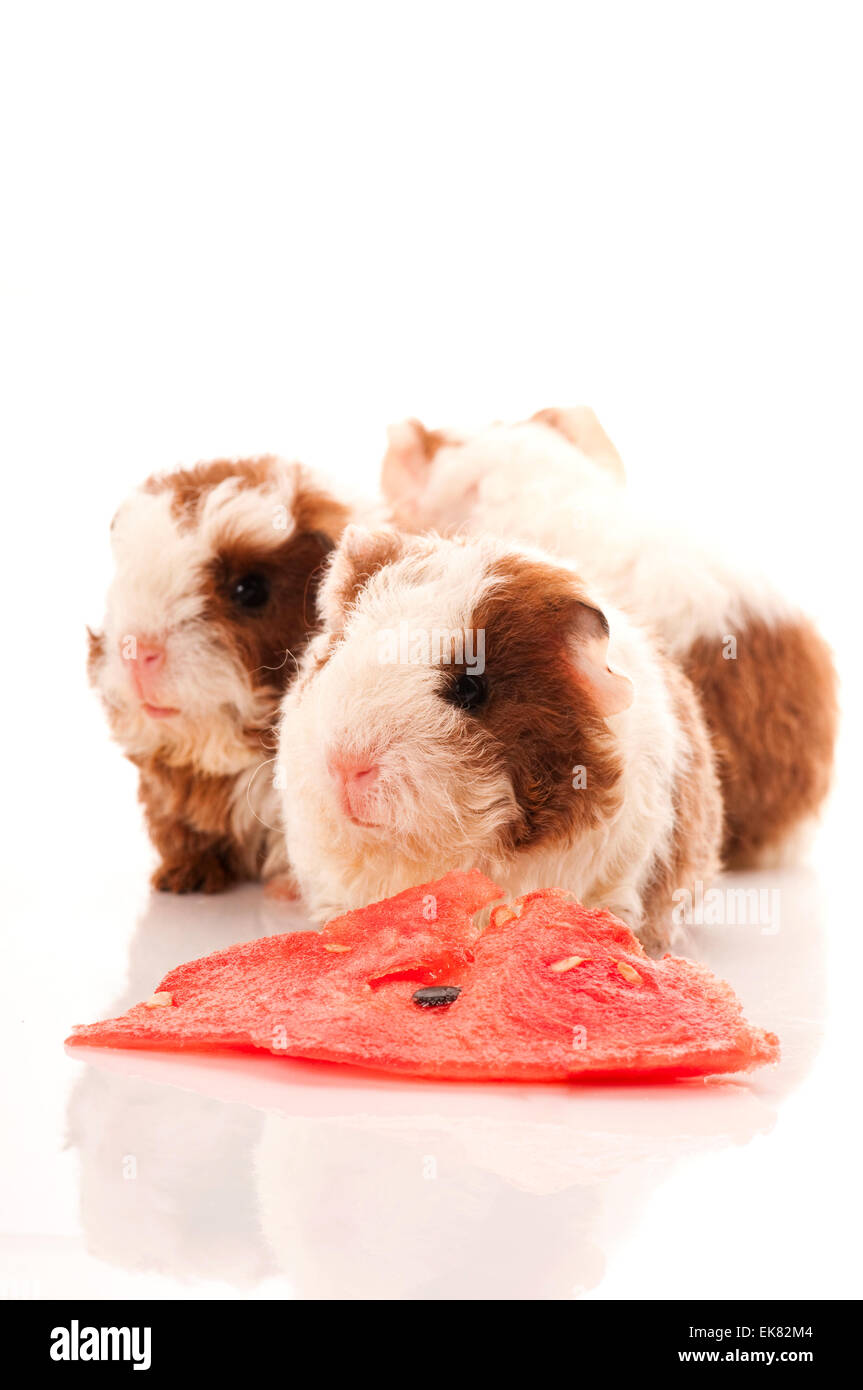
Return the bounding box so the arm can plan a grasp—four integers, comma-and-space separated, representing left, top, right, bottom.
68, 873, 778, 1081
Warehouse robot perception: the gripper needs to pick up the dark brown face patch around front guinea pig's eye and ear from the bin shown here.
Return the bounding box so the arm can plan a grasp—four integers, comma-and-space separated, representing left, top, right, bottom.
464, 556, 621, 849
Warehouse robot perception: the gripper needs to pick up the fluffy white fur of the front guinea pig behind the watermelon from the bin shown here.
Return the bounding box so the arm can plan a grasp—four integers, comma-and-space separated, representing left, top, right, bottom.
279, 528, 697, 927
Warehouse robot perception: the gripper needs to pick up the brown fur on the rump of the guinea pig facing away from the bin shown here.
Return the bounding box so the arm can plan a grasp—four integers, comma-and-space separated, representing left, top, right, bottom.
682, 619, 838, 867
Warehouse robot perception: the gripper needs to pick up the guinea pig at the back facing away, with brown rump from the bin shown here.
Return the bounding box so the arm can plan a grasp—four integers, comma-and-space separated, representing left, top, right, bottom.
382, 407, 837, 867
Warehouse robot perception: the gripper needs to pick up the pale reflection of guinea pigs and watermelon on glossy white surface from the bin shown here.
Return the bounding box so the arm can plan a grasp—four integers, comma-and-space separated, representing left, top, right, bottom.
62, 872, 823, 1298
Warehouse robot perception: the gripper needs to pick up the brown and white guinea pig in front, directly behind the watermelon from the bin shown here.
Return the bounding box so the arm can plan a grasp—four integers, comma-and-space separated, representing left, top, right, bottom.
279, 525, 721, 948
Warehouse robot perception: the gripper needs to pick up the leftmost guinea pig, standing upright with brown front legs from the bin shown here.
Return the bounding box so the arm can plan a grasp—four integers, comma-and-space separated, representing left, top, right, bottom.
89, 457, 347, 892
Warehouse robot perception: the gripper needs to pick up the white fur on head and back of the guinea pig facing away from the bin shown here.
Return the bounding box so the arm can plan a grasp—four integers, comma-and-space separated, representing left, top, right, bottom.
385, 421, 791, 655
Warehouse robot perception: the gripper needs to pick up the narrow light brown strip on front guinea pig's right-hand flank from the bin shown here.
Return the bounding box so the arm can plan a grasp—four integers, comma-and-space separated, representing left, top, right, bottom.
639, 662, 723, 952
